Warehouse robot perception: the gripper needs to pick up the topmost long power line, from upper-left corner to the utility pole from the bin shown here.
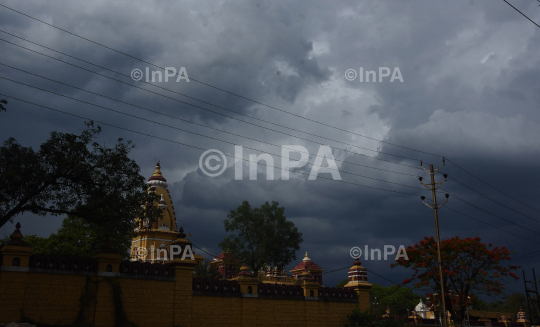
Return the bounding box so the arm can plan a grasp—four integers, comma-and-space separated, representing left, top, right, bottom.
0, 4, 440, 157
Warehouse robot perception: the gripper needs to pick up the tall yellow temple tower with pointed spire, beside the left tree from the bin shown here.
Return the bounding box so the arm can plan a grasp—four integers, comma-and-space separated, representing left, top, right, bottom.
131, 162, 184, 262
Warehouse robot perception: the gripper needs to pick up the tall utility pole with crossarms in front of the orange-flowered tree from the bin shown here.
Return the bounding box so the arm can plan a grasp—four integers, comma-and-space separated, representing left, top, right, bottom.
418, 158, 449, 327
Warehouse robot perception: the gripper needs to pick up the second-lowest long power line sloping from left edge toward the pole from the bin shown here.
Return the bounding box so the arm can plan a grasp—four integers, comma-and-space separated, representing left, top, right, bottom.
0, 76, 428, 190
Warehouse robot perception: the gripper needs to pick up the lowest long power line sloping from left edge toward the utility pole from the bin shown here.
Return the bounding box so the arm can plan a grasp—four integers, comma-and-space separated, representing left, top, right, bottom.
0, 94, 426, 200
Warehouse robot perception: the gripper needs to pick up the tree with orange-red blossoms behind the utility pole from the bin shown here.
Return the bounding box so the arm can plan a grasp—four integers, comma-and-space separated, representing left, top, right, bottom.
390, 236, 519, 321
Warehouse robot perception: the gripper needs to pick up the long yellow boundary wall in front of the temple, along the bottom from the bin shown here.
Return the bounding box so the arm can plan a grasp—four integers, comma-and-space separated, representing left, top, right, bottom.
0, 267, 358, 327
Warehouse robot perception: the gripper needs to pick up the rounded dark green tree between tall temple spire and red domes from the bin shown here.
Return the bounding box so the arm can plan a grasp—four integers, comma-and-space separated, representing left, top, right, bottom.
219, 201, 303, 275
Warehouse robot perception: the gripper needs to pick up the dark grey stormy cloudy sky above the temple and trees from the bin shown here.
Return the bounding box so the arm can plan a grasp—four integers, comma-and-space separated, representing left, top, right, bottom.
0, 0, 540, 291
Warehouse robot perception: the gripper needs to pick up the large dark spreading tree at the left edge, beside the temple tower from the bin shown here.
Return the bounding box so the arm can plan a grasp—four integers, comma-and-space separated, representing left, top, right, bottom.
0, 122, 162, 240
